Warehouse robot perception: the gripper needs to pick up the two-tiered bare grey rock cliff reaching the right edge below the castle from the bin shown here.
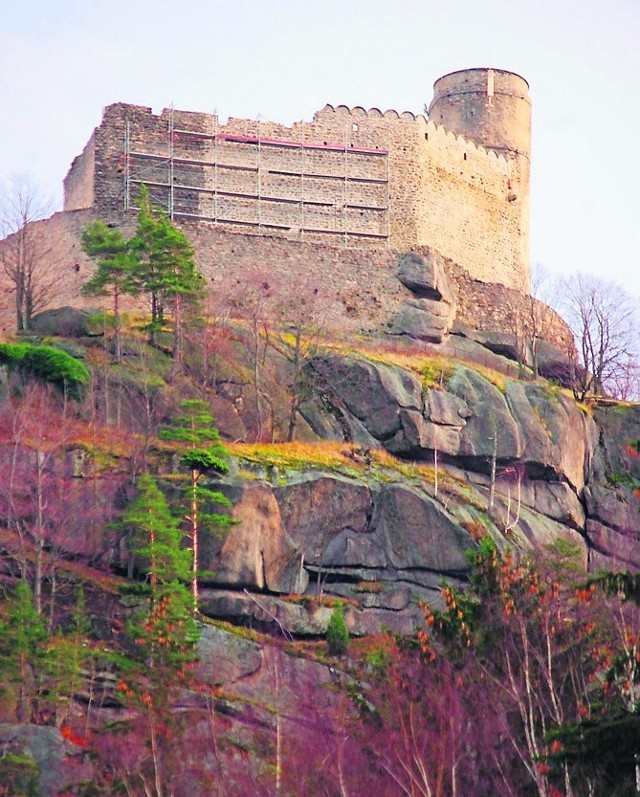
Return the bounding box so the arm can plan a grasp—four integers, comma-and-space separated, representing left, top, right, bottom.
195, 354, 640, 636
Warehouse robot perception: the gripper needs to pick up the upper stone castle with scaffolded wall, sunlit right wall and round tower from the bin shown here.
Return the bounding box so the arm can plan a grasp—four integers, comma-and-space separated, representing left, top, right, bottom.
65, 69, 530, 290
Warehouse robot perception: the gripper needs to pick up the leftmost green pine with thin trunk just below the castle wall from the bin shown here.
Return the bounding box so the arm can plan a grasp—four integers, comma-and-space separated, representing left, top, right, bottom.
82, 221, 137, 362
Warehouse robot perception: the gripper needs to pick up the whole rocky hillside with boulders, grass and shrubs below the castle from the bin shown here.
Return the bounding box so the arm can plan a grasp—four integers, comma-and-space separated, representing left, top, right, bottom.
0, 278, 640, 797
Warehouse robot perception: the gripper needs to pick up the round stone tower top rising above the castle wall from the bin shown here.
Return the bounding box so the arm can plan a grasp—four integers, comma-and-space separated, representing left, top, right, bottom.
429, 68, 531, 160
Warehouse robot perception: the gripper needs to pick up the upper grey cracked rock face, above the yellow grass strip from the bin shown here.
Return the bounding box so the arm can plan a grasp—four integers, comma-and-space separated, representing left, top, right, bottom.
302, 355, 596, 493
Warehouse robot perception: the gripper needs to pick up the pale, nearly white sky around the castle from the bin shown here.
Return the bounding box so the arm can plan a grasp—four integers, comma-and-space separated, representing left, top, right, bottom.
0, 0, 640, 295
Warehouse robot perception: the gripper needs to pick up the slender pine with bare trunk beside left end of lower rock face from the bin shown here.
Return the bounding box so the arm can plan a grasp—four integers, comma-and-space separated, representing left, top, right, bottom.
159, 399, 233, 609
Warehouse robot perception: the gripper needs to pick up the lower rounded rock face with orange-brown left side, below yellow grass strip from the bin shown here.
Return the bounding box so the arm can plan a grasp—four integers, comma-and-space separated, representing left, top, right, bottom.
201, 472, 474, 636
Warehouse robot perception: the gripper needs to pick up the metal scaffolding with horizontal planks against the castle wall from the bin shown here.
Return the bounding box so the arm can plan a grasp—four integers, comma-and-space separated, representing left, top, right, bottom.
124, 107, 391, 247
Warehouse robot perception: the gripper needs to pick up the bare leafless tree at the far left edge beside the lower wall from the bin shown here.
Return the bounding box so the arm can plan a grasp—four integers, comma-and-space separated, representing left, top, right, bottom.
0, 176, 60, 332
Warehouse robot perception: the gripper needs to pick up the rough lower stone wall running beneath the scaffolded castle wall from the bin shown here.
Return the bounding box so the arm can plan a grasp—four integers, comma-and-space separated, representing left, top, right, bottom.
0, 209, 570, 350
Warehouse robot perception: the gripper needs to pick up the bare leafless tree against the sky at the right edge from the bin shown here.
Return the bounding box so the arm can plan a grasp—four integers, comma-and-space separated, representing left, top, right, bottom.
562, 274, 640, 399
